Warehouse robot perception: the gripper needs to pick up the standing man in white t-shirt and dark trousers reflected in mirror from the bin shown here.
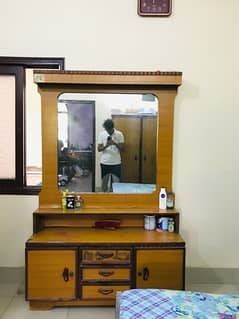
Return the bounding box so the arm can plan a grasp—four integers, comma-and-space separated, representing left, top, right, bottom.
98, 119, 124, 192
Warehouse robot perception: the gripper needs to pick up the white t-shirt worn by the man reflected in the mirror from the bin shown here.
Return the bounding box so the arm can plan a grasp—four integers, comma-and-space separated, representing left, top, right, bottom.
98, 129, 124, 165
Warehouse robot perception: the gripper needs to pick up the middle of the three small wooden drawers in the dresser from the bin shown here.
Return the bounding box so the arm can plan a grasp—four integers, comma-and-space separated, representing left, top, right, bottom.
82, 268, 130, 281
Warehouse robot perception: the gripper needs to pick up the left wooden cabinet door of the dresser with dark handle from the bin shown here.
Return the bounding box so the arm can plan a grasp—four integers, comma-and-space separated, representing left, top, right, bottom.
26, 250, 76, 300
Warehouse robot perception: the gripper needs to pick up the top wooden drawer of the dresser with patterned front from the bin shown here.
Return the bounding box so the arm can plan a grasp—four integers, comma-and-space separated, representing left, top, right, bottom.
82, 249, 130, 264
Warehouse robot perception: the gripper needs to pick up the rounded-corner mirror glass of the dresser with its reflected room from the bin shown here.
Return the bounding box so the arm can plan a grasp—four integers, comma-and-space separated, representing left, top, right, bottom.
58, 93, 159, 193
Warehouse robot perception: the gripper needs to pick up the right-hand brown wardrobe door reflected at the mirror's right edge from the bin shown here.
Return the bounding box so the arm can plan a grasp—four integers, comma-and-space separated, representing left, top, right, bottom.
141, 116, 157, 184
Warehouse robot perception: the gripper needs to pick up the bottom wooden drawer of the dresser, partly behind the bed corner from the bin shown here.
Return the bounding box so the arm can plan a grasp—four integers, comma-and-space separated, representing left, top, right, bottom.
82, 285, 130, 299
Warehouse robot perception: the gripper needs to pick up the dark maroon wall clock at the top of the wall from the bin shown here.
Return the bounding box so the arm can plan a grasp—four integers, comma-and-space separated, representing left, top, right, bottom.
138, 0, 172, 17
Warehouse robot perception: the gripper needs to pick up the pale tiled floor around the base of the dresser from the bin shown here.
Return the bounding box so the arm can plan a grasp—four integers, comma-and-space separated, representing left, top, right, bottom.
0, 283, 239, 319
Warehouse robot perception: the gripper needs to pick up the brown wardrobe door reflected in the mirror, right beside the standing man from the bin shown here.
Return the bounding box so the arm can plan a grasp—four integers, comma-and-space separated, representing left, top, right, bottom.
113, 115, 141, 183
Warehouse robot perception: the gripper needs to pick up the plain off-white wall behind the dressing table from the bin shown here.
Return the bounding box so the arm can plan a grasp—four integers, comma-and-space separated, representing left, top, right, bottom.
0, 0, 239, 268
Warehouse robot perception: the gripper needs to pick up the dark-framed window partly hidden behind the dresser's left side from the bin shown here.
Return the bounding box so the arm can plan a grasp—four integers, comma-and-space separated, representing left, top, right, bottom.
0, 57, 65, 194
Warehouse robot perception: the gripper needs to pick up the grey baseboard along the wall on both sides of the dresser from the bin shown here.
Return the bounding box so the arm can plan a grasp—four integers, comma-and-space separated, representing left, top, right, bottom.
0, 267, 239, 285
